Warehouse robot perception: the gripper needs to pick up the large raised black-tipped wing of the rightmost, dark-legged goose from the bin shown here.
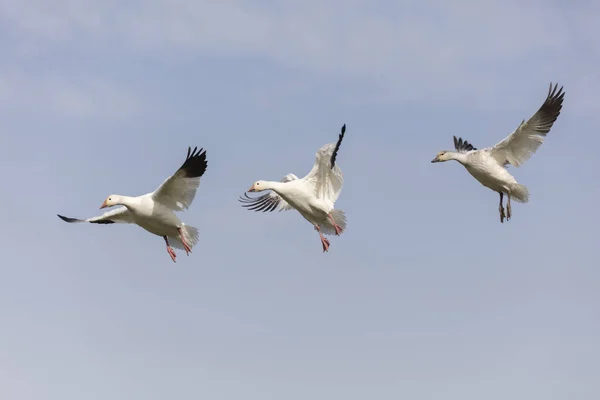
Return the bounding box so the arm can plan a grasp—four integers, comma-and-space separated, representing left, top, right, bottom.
489, 84, 565, 167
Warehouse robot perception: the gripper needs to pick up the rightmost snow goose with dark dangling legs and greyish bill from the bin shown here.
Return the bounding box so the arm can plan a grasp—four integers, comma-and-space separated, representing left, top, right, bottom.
431, 83, 565, 222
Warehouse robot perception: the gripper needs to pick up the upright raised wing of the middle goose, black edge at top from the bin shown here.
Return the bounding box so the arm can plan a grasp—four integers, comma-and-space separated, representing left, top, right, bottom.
302, 124, 346, 205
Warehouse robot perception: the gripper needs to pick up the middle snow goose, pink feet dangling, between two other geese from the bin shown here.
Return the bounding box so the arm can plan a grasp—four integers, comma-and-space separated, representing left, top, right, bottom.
240, 124, 346, 252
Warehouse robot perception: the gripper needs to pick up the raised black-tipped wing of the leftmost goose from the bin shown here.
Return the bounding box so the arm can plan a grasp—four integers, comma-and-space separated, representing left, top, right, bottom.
152, 147, 207, 211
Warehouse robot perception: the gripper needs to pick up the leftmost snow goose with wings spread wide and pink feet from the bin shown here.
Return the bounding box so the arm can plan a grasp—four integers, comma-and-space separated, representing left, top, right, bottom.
58, 147, 207, 262
